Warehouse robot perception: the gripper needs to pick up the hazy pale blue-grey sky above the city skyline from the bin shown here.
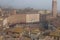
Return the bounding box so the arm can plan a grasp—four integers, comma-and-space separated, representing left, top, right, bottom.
0, 0, 60, 9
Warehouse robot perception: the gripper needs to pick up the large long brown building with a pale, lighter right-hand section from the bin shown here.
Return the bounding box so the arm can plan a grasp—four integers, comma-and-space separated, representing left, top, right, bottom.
4, 13, 40, 24
